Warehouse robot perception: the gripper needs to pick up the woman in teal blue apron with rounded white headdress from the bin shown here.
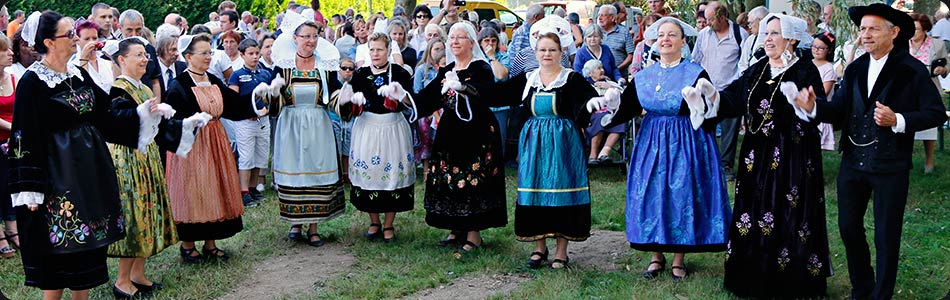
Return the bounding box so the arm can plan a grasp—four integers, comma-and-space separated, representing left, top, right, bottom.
492, 17, 597, 269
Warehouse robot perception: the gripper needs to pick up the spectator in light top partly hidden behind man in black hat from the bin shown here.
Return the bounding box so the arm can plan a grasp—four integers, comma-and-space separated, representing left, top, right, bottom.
910, 14, 947, 173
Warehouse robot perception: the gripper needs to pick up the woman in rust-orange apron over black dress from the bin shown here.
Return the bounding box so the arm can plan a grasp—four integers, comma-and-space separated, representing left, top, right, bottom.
165, 34, 259, 263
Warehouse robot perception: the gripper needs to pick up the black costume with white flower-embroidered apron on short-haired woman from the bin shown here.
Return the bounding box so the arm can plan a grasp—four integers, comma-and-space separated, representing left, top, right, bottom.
330, 64, 416, 213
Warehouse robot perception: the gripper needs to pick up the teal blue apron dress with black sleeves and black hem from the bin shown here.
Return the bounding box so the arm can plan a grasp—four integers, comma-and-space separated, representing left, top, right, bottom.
498, 69, 597, 242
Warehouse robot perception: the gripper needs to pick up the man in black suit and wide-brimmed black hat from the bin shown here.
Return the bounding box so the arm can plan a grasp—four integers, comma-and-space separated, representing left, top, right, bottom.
795, 4, 947, 299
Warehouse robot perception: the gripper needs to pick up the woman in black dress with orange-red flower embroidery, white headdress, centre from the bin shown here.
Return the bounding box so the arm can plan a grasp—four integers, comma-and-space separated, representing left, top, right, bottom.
416, 22, 508, 258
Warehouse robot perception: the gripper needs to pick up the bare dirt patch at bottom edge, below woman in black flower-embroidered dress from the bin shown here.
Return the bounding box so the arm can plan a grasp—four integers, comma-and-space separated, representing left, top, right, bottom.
403, 274, 531, 300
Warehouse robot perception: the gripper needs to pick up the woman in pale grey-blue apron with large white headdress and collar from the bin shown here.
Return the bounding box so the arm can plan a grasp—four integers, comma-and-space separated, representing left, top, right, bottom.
271, 11, 355, 247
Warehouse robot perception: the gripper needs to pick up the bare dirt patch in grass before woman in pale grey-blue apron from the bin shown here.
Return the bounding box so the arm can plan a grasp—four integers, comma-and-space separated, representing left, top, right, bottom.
219, 243, 356, 300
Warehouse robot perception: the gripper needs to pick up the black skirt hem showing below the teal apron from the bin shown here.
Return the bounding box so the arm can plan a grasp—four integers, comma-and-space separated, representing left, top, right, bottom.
515, 204, 590, 242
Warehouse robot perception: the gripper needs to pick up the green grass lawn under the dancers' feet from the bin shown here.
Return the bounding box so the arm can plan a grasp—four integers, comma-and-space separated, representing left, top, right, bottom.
0, 132, 950, 299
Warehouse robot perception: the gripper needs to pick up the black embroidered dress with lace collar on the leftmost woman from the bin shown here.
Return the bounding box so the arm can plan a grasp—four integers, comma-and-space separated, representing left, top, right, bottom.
7, 62, 151, 290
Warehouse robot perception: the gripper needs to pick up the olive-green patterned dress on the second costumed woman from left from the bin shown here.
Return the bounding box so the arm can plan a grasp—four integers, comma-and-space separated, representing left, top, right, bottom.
108, 77, 181, 257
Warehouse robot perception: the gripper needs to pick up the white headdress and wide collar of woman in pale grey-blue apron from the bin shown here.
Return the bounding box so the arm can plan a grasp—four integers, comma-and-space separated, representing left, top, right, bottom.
270, 10, 340, 71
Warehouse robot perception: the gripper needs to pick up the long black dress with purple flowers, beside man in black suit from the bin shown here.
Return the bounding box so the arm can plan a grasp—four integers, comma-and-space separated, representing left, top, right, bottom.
719, 58, 832, 298
